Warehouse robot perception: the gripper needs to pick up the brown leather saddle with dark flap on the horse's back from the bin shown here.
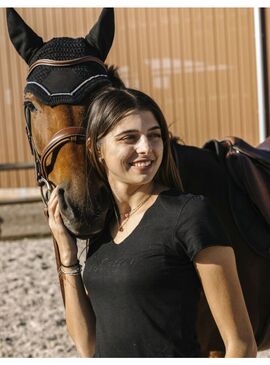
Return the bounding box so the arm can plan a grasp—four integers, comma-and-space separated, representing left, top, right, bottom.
203, 137, 270, 258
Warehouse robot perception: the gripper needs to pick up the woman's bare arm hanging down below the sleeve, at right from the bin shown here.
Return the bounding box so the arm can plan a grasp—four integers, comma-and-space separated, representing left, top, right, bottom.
194, 246, 257, 357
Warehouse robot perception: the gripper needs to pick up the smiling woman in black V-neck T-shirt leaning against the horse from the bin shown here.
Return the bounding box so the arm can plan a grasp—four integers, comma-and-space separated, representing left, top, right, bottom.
49, 88, 256, 357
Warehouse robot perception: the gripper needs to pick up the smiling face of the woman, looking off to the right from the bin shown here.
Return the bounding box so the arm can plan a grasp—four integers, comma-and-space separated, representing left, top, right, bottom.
100, 111, 163, 186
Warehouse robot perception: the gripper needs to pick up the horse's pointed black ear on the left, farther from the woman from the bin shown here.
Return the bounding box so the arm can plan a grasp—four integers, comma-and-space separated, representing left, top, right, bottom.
7, 8, 43, 64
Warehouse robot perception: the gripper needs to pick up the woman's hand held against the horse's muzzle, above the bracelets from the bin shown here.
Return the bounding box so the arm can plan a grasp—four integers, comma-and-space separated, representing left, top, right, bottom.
48, 187, 78, 266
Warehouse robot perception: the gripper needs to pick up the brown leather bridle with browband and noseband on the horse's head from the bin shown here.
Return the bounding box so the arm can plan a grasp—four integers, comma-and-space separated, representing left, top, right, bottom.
24, 56, 106, 207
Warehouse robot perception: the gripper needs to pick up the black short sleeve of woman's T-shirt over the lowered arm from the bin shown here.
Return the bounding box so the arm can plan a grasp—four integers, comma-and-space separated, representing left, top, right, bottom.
175, 195, 231, 260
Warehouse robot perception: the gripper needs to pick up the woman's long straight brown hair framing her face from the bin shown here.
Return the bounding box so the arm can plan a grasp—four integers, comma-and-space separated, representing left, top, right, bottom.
86, 87, 183, 191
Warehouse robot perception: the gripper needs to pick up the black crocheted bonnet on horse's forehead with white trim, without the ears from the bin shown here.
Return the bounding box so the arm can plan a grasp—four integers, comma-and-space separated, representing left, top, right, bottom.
25, 38, 109, 106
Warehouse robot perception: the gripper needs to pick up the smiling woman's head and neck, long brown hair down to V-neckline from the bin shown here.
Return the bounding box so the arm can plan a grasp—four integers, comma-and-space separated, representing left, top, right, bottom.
86, 88, 182, 241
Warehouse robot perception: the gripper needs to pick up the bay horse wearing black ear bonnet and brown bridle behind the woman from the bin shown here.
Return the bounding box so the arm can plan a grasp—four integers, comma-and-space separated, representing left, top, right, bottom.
7, 9, 270, 357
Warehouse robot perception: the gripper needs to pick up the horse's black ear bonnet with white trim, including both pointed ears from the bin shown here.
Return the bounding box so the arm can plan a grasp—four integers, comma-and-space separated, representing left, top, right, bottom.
7, 9, 114, 106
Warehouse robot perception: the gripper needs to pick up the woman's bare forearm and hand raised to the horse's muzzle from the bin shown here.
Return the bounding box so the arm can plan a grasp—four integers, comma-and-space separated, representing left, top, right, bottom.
48, 188, 95, 357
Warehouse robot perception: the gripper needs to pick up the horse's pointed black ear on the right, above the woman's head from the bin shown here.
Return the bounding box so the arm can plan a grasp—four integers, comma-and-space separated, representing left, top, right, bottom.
85, 8, 114, 61
